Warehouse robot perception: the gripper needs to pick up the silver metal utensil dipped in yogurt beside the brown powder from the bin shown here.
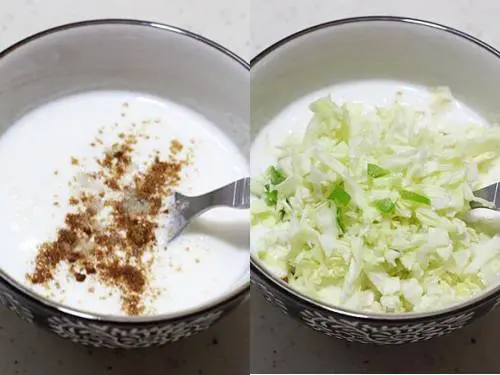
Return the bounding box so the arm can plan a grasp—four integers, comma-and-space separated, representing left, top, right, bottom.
168, 177, 250, 242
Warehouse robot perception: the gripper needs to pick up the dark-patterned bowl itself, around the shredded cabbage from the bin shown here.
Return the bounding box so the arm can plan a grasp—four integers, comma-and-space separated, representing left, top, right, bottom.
250, 16, 500, 344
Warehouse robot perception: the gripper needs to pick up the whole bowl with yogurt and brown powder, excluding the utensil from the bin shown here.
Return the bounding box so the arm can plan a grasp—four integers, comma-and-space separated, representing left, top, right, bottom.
0, 20, 249, 348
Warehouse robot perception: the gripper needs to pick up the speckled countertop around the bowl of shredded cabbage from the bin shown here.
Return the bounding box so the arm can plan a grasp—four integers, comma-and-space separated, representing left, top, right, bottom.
254, 0, 500, 374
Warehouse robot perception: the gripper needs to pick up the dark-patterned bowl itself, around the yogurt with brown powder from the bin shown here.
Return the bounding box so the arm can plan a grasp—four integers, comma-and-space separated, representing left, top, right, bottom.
0, 19, 250, 348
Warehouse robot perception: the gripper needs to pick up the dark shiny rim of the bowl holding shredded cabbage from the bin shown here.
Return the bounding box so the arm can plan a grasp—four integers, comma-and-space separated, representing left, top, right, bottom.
250, 15, 500, 324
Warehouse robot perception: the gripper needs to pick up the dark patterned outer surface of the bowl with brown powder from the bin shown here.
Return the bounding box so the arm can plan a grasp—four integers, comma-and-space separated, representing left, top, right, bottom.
0, 280, 248, 349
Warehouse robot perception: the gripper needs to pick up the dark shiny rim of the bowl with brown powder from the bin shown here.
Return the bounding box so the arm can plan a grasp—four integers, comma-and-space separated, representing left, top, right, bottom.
0, 18, 250, 325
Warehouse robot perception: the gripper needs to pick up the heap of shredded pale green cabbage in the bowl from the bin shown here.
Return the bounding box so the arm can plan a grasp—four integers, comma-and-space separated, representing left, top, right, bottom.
251, 89, 500, 313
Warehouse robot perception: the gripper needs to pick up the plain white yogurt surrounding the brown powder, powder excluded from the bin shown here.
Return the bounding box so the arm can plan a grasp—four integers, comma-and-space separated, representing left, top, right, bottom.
0, 91, 249, 315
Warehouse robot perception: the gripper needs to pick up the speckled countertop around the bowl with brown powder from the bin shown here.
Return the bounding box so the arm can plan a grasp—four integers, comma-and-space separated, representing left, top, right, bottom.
0, 0, 250, 375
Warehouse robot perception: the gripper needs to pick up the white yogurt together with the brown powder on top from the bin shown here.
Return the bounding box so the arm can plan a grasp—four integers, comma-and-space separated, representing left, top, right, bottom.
0, 91, 248, 315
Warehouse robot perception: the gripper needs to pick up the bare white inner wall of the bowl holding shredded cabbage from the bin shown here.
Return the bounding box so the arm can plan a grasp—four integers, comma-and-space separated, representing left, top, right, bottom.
251, 20, 500, 137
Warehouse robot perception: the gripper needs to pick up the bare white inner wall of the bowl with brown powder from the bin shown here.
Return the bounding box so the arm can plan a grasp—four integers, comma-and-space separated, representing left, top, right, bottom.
0, 21, 250, 318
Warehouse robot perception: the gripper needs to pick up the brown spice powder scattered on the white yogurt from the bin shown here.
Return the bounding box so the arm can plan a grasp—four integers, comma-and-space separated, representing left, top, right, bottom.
27, 133, 188, 315
